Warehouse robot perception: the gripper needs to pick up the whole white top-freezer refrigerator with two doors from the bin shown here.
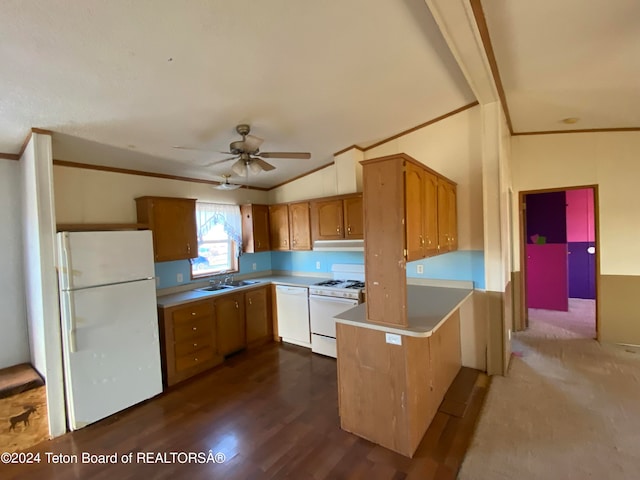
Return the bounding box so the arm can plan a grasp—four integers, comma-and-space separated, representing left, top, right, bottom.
57, 230, 162, 430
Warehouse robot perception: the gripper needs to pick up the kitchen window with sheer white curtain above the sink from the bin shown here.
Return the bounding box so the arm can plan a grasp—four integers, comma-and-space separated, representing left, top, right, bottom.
191, 202, 242, 278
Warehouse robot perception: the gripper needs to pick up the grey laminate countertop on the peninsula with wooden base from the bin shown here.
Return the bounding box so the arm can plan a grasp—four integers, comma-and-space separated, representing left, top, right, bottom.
335, 285, 473, 337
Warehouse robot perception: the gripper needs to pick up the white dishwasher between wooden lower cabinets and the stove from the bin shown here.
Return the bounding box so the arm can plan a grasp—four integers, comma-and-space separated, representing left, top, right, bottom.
276, 285, 311, 348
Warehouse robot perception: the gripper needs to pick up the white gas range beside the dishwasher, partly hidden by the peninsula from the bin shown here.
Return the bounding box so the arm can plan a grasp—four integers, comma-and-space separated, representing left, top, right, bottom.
309, 264, 364, 358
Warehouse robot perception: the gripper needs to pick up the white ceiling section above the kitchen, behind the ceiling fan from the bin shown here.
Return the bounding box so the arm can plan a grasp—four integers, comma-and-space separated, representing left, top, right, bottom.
0, 0, 476, 187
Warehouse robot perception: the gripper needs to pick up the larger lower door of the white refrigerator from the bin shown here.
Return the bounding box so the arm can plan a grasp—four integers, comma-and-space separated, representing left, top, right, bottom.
60, 280, 162, 430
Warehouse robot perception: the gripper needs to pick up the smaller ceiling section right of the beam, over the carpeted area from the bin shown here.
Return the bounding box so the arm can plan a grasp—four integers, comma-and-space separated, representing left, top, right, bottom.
482, 0, 640, 132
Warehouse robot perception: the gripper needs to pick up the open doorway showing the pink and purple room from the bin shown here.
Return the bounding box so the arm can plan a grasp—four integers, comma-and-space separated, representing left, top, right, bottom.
520, 185, 599, 338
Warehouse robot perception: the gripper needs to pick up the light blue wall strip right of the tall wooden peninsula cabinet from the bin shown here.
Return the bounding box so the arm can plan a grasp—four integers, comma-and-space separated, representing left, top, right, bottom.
407, 250, 484, 289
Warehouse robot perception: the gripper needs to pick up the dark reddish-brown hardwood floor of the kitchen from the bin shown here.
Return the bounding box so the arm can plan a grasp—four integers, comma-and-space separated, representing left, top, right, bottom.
0, 344, 489, 480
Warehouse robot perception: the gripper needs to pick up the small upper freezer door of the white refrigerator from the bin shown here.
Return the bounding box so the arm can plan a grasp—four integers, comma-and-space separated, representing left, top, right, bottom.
58, 230, 155, 290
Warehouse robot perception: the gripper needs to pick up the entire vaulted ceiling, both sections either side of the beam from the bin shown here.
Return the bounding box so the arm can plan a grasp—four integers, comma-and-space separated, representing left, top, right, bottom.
0, 0, 640, 187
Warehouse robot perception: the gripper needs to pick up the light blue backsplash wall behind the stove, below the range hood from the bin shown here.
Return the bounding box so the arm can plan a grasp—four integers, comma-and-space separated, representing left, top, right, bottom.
271, 252, 364, 273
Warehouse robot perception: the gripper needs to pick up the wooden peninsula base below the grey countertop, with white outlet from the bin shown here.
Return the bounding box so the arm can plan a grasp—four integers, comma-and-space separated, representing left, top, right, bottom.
336, 311, 461, 457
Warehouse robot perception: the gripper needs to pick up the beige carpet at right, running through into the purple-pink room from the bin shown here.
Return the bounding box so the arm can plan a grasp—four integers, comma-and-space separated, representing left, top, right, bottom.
458, 301, 640, 480
